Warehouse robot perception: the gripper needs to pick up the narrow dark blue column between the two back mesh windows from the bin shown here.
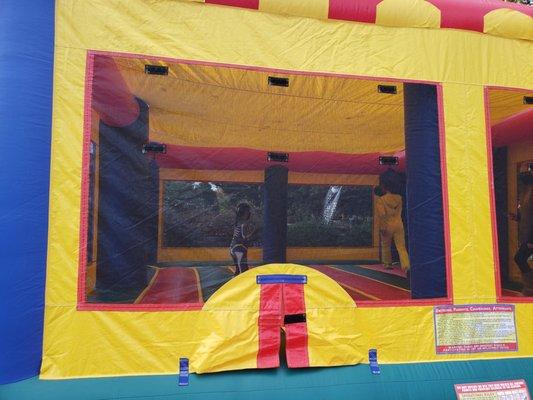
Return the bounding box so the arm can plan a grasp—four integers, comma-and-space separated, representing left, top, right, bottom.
263, 165, 289, 263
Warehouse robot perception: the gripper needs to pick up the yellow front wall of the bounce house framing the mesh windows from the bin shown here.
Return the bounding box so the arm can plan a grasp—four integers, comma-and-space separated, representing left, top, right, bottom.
41, 0, 533, 379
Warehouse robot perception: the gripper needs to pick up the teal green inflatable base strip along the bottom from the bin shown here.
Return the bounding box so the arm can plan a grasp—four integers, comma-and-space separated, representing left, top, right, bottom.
0, 358, 533, 400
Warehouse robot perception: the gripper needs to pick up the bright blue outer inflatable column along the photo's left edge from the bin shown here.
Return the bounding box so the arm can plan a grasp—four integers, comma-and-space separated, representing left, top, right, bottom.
0, 0, 55, 384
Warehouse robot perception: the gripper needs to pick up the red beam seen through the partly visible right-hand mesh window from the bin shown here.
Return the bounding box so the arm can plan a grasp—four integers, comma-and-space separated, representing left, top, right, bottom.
492, 108, 533, 147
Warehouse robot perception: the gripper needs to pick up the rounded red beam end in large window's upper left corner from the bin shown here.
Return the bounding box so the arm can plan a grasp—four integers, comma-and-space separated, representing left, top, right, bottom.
92, 56, 140, 126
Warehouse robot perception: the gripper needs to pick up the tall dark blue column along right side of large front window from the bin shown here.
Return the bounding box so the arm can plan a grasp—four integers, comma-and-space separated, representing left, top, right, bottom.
404, 83, 446, 299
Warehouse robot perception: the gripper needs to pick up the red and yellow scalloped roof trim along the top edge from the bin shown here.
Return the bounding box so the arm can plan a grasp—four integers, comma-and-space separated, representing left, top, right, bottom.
189, 0, 533, 41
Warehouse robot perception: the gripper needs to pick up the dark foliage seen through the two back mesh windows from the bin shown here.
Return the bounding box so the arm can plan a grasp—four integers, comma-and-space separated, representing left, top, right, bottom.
163, 181, 373, 247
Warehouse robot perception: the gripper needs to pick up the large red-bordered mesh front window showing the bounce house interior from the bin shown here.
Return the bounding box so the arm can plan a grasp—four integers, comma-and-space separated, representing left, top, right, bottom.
80, 53, 447, 304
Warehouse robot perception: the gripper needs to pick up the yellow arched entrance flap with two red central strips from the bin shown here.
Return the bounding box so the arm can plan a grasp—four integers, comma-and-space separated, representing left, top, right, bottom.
193, 264, 358, 372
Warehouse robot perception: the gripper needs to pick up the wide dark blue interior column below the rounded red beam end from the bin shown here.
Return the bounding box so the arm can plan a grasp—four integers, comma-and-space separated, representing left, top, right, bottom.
96, 100, 159, 299
